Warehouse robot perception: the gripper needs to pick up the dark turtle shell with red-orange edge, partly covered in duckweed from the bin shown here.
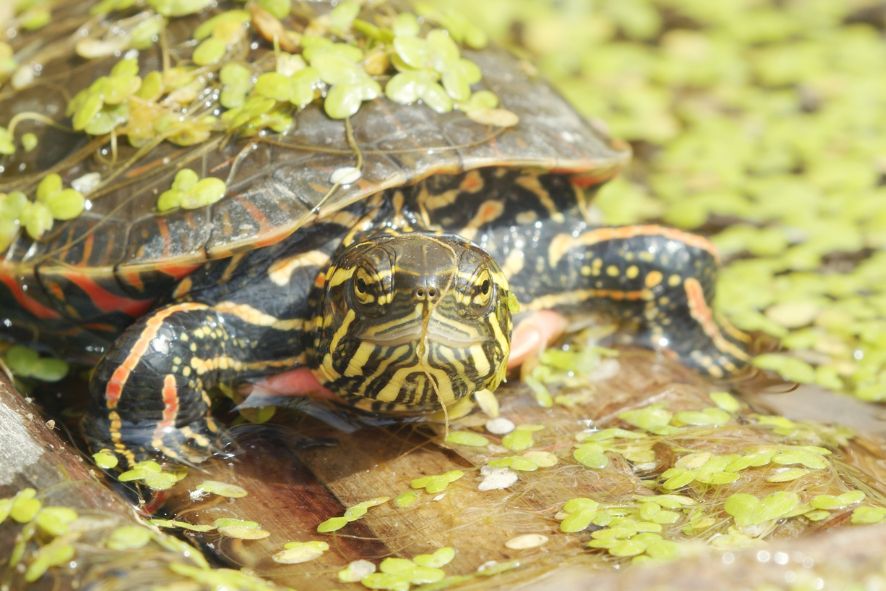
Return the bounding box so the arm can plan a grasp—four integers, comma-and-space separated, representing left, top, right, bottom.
0, 3, 629, 356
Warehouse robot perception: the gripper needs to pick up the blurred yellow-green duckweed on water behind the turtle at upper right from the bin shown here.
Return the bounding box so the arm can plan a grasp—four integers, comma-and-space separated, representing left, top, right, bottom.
426, 0, 886, 401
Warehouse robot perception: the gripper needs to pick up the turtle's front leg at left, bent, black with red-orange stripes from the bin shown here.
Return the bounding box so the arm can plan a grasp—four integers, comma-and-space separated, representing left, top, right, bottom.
84, 302, 302, 464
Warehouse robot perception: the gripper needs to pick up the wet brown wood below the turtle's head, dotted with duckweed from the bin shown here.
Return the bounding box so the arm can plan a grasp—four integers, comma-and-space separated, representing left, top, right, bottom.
156, 350, 882, 591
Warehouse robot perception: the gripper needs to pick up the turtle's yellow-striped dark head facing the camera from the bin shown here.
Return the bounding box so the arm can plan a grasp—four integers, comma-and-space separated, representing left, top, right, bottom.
314, 233, 511, 413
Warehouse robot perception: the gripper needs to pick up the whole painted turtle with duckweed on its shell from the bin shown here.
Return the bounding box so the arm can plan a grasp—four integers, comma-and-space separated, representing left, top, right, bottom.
0, 3, 747, 462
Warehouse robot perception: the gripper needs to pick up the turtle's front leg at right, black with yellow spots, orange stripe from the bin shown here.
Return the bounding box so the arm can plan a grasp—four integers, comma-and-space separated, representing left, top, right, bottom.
526, 224, 750, 378
